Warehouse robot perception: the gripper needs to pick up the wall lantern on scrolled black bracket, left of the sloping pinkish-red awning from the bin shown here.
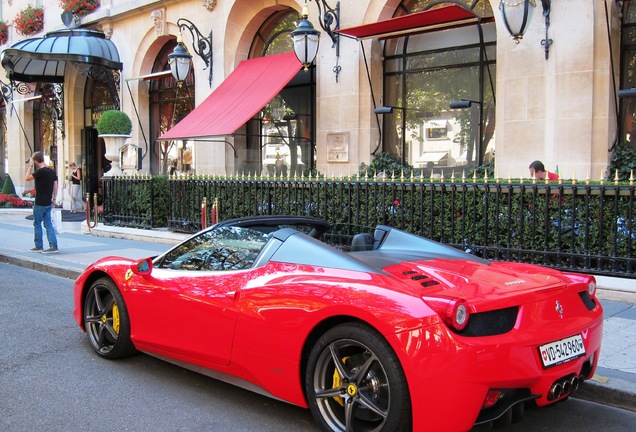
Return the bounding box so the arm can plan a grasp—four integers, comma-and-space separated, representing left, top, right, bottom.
168, 18, 212, 87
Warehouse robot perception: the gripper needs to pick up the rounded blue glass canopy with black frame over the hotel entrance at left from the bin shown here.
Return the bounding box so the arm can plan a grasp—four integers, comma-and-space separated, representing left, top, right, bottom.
2, 28, 123, 83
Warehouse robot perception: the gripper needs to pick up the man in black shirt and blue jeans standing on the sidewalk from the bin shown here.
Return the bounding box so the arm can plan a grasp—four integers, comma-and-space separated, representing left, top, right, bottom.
26, 152, 57, 253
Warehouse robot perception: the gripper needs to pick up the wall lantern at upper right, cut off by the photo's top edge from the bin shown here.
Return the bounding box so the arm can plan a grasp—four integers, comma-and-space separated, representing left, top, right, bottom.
499, 0, 552, 60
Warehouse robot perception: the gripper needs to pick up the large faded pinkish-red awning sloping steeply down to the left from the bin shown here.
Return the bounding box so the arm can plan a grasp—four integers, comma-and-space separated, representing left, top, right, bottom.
158, 52, 302, 141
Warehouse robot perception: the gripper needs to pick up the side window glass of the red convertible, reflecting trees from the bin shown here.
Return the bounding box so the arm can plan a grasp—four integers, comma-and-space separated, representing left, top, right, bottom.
158, 227, 269, 271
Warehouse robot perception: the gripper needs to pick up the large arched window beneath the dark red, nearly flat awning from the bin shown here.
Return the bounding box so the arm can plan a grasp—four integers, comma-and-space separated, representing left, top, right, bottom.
382, 0, 496, 175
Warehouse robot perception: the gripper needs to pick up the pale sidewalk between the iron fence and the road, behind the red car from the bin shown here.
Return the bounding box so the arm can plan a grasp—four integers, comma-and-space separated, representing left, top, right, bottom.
0, 209, 636, 411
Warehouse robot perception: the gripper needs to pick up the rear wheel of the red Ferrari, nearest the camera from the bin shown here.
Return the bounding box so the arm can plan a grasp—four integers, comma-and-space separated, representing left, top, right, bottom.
305, 323, 412, 432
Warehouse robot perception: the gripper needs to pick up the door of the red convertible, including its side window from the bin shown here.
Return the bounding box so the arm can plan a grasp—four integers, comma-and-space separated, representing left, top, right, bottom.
130, 227, 268, 365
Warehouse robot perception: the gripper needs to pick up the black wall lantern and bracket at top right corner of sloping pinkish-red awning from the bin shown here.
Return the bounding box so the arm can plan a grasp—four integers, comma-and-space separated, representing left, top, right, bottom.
291, 0, 341, 82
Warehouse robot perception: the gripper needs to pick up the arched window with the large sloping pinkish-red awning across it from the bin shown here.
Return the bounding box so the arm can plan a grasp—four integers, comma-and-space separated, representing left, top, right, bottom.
241, 9, 316, 177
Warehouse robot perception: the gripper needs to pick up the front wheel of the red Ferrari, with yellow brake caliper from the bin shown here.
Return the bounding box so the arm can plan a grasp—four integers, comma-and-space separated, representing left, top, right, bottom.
84, 278, 135, 359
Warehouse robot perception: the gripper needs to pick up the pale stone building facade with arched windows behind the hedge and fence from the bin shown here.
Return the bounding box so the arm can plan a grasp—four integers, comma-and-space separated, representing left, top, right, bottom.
0, 0, 631, 205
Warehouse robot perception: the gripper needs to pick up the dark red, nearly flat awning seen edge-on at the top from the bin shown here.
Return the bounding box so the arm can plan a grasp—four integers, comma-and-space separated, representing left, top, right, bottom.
337, 4, 477, 39
